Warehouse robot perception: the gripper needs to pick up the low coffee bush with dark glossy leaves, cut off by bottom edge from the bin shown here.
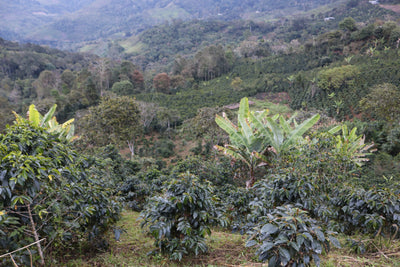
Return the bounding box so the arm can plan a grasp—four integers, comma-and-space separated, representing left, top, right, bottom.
246, 205, 340, 266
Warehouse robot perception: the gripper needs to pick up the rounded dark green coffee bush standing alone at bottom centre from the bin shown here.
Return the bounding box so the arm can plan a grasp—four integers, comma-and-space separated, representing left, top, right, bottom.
141, 174, 223, 261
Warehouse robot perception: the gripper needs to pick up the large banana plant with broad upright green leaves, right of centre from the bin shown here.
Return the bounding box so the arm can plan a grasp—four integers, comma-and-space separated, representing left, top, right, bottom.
215, 98, 319, 188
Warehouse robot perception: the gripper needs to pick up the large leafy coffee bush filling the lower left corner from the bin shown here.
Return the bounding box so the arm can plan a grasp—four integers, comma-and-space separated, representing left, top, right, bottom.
0, 123, 120, 264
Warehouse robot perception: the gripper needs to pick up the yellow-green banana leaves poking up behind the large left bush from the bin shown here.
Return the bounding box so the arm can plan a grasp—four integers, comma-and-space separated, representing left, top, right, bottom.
13, 104, 77, 142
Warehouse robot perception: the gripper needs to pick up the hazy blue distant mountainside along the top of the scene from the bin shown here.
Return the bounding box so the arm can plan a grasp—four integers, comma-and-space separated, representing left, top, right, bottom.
0, 0, 343, 46
